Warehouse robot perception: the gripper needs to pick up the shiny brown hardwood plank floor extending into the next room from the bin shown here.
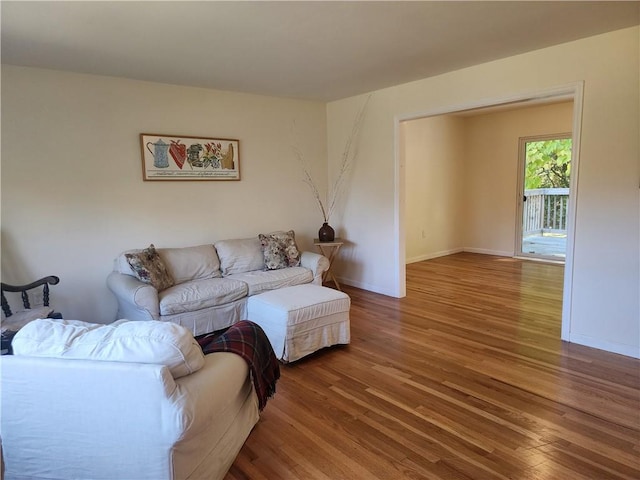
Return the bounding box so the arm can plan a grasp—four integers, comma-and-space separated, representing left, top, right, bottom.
226, 253, 640, 480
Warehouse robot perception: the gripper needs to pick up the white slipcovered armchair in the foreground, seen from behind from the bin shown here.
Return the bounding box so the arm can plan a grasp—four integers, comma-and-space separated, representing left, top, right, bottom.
0, 319, 259, 480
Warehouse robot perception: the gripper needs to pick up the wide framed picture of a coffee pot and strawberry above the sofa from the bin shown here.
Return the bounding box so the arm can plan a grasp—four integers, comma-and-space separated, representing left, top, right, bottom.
140, 133, 240, 181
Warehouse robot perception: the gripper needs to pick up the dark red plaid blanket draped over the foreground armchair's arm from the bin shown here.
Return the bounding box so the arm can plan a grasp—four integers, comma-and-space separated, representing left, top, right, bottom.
195, 320, 280, 411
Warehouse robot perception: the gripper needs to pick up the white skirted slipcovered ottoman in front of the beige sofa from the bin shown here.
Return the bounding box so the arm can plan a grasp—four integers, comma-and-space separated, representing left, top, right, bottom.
247, 283, 351, 362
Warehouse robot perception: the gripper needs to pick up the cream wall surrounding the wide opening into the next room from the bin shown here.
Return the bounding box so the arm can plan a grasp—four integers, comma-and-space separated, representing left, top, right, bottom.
327, 27, 640, 356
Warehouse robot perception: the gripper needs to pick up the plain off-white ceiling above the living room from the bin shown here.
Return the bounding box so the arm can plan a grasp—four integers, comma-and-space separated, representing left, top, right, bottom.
0, 0, 640, 101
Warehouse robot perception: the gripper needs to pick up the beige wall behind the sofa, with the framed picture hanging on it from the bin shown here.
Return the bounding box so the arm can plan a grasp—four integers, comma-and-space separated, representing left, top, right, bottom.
1, 66, 326, 322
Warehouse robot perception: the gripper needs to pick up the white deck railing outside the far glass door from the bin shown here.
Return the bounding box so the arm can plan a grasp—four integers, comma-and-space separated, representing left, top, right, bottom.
522, 188, 569, 235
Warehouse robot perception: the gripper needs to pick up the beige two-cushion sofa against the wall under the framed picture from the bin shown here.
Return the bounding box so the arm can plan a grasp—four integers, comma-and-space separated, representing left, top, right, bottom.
107, 232, 329, 335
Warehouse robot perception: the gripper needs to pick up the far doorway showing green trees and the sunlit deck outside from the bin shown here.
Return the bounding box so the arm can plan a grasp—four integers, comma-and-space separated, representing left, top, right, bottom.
515, 133, 572, 263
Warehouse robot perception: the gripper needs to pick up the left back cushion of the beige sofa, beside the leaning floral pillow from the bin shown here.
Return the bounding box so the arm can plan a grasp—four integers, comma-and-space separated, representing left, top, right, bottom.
158, 245, 222, 284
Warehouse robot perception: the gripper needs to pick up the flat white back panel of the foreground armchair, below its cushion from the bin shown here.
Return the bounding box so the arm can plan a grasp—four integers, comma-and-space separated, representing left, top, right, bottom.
0, 355, 180, 480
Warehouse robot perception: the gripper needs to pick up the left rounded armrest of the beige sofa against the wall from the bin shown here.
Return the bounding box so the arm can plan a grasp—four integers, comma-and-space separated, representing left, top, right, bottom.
107, 272, 160, 320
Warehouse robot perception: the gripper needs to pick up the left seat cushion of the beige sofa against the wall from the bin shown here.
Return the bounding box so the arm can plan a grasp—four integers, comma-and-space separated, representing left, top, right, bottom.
158, 278, 248, 315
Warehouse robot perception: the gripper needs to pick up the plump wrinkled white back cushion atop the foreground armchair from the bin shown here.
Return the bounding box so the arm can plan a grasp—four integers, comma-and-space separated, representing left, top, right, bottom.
11, 319, 204, 378
